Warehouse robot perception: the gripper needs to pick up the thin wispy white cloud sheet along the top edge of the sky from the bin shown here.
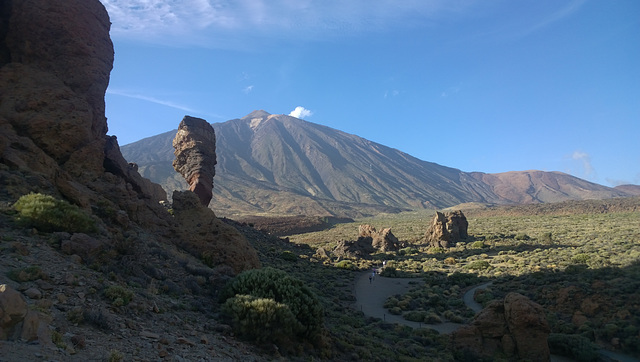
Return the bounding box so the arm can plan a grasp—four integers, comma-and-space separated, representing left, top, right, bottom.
101, 0, 472, 43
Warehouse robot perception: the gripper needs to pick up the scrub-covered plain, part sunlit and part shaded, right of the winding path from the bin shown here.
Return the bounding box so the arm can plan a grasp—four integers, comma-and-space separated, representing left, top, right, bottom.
289, 198, 640, 360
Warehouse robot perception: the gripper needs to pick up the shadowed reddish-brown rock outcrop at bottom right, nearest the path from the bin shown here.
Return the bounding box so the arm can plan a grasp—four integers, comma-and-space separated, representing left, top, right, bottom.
452, 293, 551, 361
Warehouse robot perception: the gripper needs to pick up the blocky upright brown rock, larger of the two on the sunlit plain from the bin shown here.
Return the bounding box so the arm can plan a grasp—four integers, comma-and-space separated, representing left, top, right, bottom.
425, 210, 469, 248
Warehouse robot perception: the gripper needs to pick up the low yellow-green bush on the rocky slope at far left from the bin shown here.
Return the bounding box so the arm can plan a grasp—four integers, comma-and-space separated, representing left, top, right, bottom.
13, 193, 97, 233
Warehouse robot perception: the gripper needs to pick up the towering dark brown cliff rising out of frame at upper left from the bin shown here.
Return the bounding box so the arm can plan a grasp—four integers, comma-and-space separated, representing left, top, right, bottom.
0, 0, 169, 225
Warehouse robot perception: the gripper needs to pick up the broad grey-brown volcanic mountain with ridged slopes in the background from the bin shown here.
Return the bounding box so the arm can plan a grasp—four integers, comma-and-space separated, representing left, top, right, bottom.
121, 111, 629, 217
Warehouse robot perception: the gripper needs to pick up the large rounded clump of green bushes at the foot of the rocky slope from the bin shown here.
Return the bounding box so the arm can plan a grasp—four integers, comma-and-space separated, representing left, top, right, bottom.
222, 267, 324, 347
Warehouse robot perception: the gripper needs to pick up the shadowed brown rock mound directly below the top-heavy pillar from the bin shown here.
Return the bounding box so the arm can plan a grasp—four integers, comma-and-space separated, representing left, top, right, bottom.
173, 191, 260, 273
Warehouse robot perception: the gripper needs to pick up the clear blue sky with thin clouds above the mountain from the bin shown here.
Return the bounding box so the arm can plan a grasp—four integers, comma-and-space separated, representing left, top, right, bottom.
101, 0, 640, 186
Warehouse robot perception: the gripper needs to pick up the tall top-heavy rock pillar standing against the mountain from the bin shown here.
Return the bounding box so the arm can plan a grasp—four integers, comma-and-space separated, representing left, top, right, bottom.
173, 116, 216, 207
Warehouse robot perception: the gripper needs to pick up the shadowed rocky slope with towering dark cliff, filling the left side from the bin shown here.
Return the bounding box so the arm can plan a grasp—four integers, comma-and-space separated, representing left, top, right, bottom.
0, 0, 260, 361
